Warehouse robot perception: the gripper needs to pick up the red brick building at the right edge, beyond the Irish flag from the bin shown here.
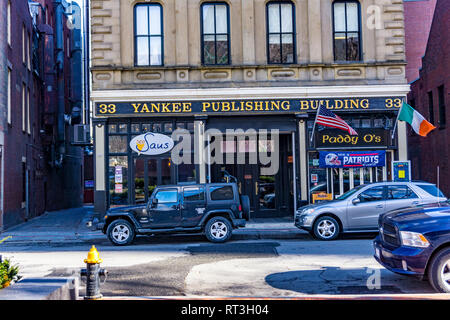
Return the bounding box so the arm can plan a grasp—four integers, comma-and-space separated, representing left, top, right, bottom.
408, 0, 450, 197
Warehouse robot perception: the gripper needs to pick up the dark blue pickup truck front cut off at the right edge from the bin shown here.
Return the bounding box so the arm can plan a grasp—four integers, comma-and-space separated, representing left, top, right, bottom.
373, 201, 450, 293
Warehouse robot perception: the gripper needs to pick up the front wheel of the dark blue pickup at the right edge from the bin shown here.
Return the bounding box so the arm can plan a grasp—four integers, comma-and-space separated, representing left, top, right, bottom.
428, 248, 450, 293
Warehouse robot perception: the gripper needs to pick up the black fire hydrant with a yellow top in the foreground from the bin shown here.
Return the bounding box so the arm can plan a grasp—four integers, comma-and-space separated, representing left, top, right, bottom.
81, 246, 108, 300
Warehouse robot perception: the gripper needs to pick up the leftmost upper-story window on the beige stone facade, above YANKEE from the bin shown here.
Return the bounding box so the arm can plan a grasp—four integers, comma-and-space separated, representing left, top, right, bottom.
134, 3, 164, 66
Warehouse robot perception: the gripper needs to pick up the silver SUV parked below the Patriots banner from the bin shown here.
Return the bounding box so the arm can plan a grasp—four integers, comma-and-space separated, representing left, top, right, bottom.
295, 182, 447, 240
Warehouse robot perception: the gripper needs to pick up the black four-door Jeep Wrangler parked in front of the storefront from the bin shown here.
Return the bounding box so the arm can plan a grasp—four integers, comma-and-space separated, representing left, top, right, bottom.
94, 183, 250, 246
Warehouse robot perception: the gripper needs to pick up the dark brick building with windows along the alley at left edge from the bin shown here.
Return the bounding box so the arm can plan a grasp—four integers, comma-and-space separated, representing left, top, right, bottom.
0, 0, 83, 230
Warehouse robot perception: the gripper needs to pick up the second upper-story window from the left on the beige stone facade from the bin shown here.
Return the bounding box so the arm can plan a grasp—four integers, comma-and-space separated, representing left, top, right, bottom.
201, 2, 230, 65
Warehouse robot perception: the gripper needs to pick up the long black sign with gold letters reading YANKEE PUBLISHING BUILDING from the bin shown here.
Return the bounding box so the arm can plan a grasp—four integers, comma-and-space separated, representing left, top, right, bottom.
95, 97, 403, 116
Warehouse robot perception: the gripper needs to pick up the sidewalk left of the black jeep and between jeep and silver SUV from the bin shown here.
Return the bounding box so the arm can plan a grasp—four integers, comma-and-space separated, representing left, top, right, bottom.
0, 206, 308, 245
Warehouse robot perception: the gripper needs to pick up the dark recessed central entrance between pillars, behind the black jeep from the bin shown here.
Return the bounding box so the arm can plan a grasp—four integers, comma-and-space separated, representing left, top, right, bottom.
209, 134, 294, 217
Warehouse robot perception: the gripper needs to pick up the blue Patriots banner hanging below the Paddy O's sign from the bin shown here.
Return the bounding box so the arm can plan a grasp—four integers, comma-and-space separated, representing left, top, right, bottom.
319, 151, 386, 168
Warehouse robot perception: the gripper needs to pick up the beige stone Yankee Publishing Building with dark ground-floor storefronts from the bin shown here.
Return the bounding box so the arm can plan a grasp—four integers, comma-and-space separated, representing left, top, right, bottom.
90, 0, 409, 216
